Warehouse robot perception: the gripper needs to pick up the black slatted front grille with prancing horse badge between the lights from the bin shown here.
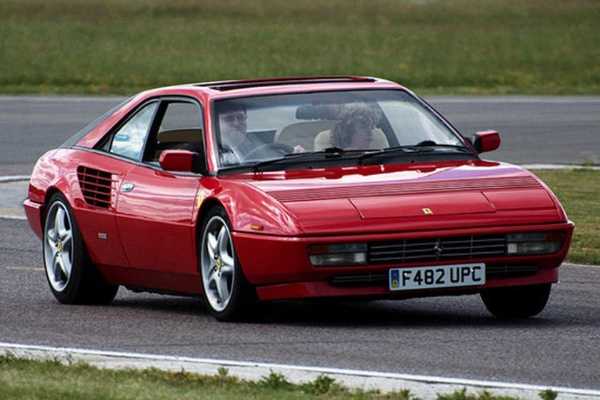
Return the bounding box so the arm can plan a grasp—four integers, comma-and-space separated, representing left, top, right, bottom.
368, 235, 506, 264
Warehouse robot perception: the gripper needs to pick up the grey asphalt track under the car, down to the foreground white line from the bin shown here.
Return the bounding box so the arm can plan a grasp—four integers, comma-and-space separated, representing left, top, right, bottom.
0, 219, 600, 389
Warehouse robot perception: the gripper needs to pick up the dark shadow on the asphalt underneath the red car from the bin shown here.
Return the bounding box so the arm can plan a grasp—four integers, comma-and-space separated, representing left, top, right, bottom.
114, 295, 556, 328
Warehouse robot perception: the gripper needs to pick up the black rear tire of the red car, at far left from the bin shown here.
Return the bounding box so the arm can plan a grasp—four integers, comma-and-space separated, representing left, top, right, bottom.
42, 193, 119, 304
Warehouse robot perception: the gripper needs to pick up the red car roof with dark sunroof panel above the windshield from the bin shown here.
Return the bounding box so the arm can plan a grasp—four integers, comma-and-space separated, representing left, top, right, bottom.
150, 75, 403, 98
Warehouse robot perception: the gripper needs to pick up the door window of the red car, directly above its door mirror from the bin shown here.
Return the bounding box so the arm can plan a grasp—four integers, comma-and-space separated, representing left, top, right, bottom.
145, 100, 204, 162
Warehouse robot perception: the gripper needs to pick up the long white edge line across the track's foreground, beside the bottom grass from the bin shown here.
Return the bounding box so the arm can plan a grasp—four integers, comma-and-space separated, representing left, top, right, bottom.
0, 342, 600, 396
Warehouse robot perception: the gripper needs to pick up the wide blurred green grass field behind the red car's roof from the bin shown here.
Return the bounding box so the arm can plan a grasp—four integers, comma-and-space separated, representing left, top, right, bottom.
0, 0, 600, 94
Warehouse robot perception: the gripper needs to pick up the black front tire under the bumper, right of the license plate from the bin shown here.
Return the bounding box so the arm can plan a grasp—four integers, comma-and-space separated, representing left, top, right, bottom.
481, 283, 552, 319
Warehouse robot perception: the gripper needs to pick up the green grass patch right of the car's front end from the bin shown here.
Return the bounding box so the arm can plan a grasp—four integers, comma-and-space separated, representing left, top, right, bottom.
534, 169, 600, 265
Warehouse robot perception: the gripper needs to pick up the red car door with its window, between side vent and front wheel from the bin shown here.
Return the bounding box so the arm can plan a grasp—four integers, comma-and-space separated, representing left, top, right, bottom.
117, 97, 204, 291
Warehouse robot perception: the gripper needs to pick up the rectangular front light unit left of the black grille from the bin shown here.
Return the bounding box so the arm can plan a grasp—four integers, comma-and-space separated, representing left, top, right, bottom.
308, 243, 367, 266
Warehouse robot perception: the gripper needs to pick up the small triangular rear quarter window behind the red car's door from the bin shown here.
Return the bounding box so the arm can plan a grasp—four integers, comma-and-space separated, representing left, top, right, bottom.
109, 102, 158, 160
